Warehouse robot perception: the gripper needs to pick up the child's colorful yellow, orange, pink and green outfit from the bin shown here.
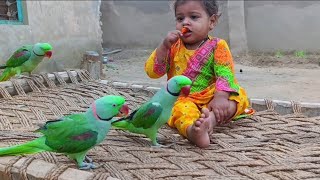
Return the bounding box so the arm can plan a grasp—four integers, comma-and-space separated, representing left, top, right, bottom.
145, 37, 249, 136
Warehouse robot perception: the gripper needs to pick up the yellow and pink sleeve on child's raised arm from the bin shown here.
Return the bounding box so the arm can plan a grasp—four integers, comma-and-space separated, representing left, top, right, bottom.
144, 50, 169, 79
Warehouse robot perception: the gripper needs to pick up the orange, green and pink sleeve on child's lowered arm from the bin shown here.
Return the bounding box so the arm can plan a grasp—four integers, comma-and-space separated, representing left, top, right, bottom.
214, 39, 240, 94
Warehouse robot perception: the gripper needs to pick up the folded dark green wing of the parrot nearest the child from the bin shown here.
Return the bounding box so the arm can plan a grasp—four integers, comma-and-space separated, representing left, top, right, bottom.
131, 102, 162, 129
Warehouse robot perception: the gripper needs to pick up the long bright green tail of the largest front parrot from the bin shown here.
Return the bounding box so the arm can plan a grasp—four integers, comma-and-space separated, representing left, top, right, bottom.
0, 137, 50, 156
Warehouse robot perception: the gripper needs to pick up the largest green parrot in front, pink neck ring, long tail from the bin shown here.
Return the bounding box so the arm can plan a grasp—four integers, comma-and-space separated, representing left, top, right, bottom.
0, 95, 129, 169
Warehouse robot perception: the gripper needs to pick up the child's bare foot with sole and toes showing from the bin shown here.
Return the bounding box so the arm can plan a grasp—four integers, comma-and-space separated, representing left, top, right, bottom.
187, 108, 217, 148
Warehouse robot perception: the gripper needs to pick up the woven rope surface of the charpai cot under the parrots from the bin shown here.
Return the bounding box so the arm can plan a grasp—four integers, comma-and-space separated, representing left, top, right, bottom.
0, 70, 320, 180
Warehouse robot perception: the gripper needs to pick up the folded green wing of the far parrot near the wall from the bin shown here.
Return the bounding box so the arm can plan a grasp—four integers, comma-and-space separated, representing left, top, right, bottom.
6, 45, 32, 67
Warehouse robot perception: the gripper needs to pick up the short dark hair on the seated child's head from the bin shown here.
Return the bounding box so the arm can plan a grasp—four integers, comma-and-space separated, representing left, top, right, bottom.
173, 0, 219, 16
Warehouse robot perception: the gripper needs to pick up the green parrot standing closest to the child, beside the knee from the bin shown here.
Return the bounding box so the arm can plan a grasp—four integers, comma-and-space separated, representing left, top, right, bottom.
112, 75, 192, 146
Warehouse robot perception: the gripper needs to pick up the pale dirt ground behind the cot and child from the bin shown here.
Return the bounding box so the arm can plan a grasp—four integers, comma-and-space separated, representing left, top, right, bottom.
104, 49, 320, 103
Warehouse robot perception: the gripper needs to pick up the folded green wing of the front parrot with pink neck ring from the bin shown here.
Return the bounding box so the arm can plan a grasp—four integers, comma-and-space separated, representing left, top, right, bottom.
38, 114, 98, 153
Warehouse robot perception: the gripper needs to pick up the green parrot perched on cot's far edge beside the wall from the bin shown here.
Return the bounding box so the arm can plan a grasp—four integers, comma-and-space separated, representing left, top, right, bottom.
0, 43, 52, 81
